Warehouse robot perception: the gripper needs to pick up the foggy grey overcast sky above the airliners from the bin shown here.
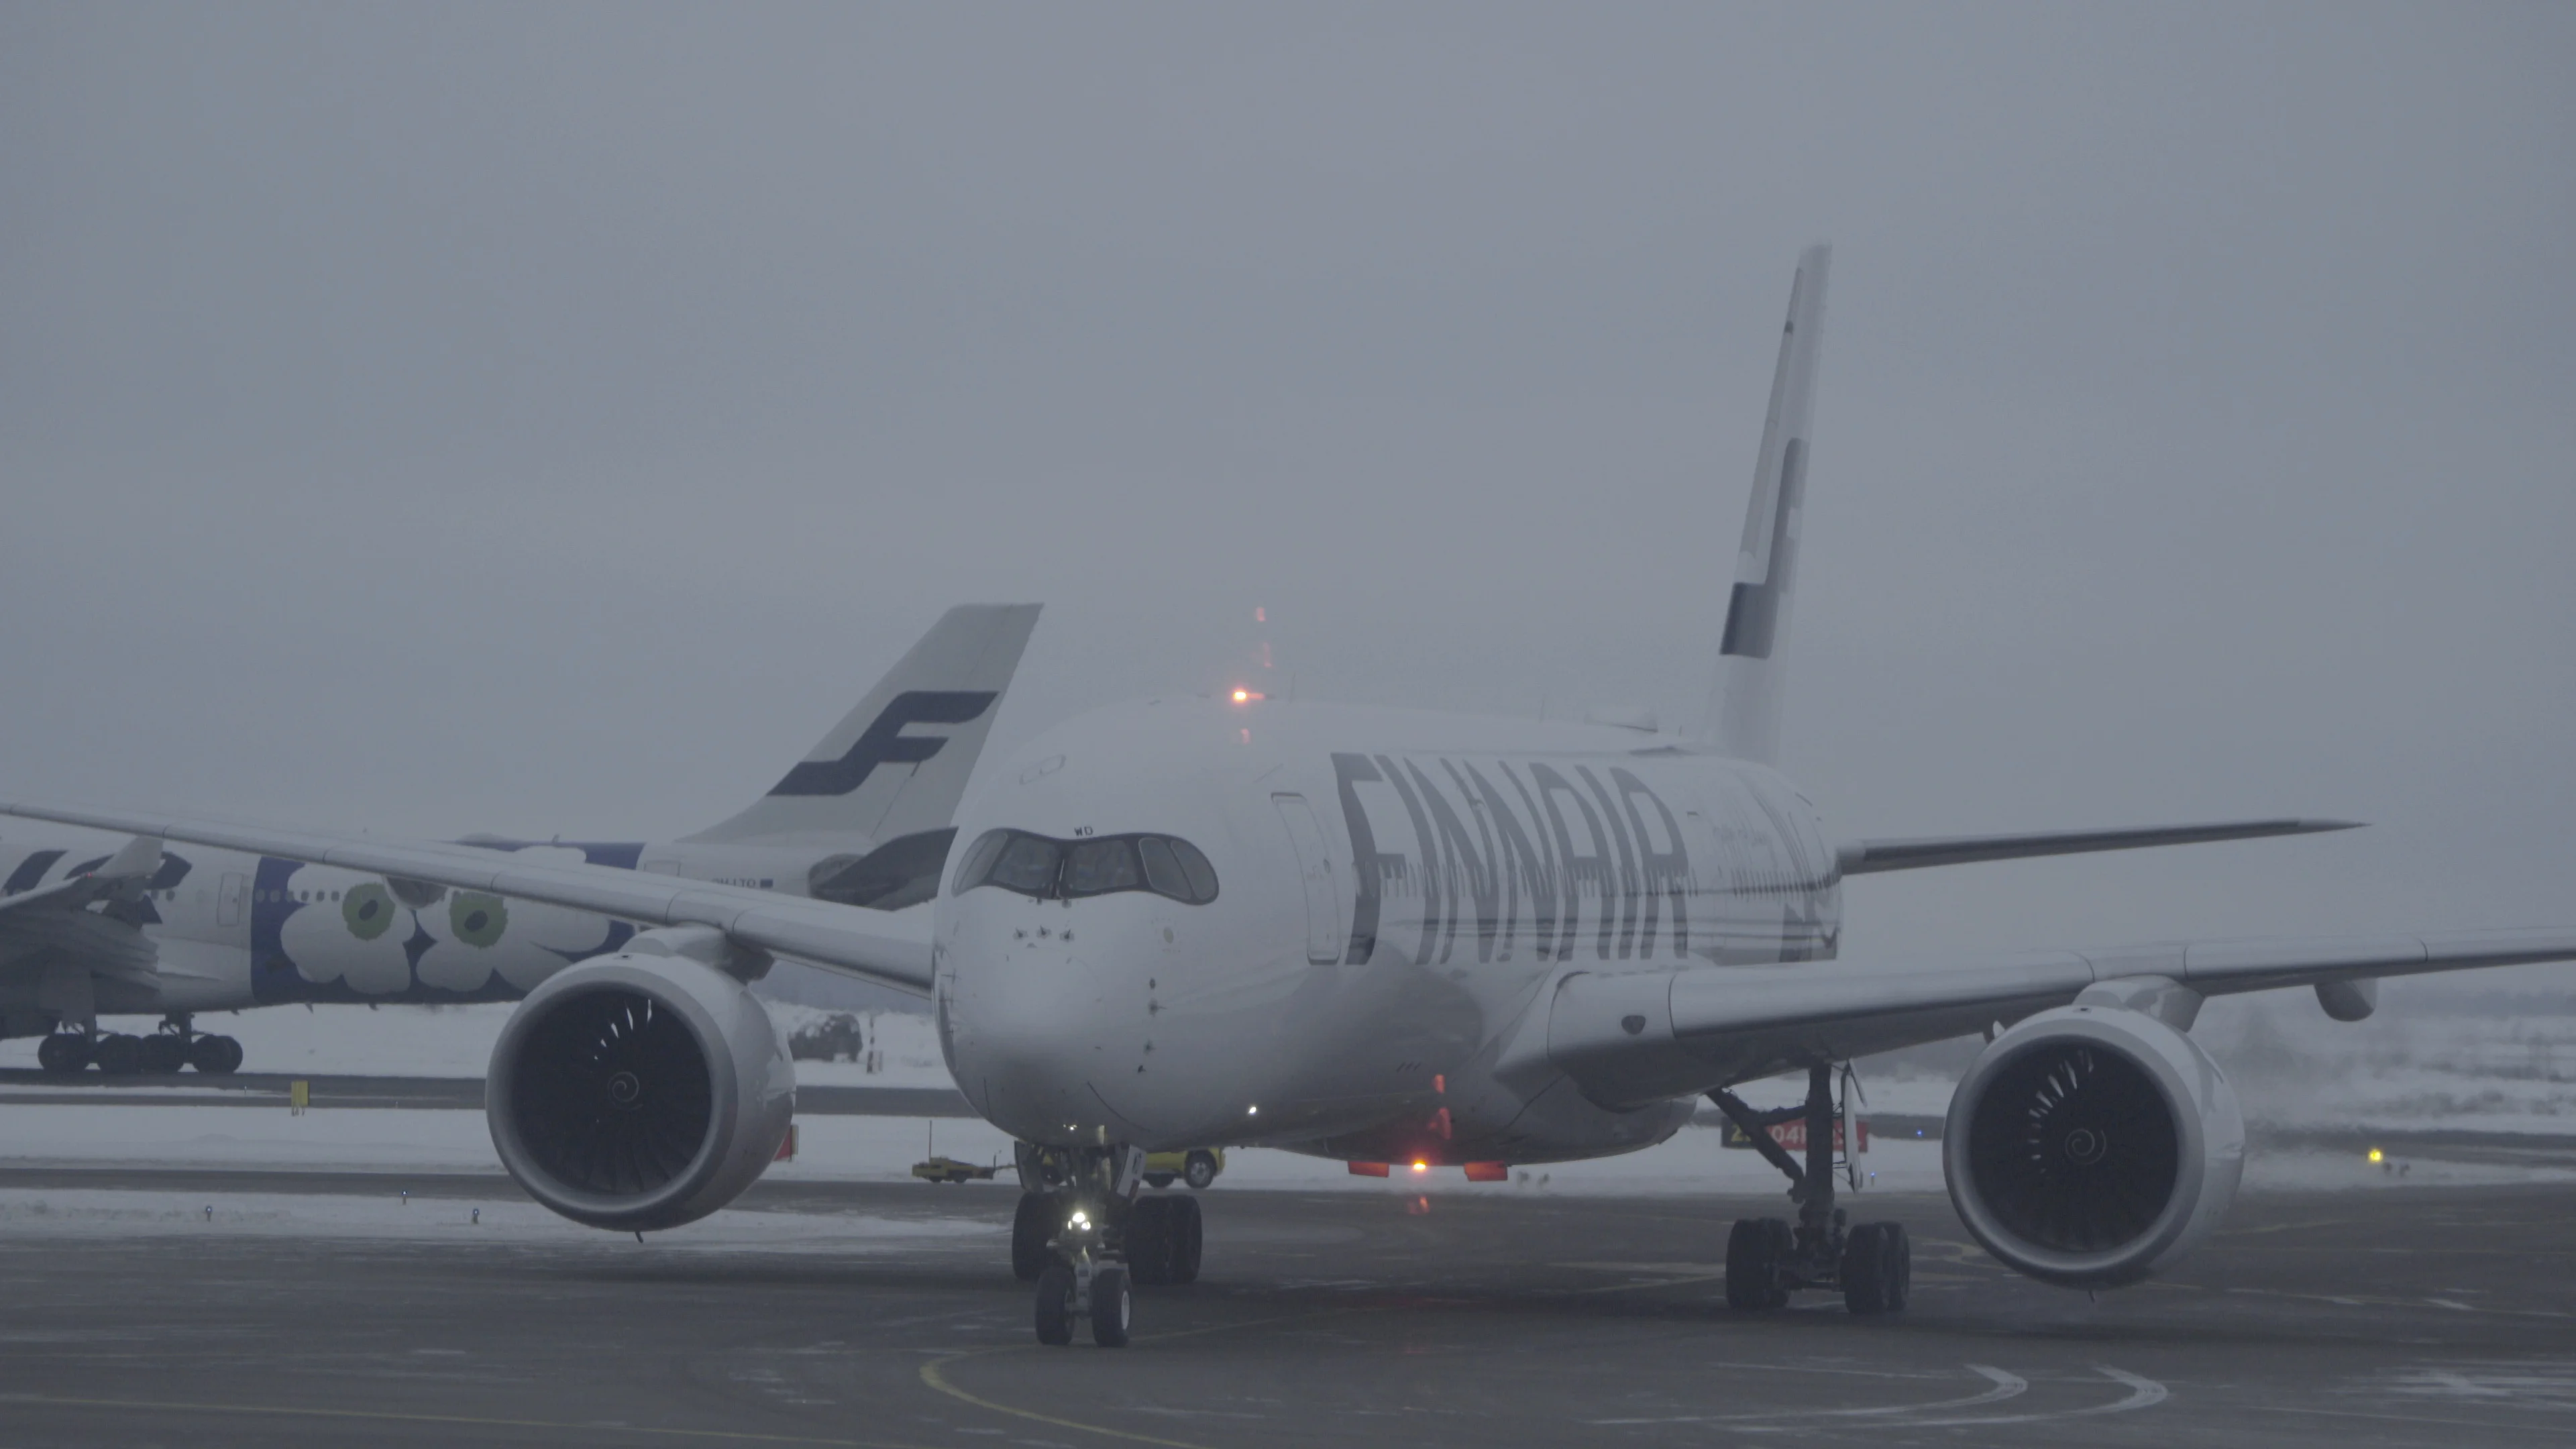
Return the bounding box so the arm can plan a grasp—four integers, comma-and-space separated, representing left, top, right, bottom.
0, 3, 2576, 979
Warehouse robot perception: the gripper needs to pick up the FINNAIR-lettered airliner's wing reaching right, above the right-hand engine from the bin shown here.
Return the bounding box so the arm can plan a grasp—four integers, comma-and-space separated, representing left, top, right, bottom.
1499, 926, 2576, 1106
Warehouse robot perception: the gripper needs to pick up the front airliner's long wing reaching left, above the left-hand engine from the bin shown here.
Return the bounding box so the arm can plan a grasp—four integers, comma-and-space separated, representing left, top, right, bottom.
0, 802, 930, 996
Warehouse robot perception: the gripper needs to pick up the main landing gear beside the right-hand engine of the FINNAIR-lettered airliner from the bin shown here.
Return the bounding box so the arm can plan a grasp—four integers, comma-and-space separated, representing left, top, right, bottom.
1708, 1067, 1914, 1315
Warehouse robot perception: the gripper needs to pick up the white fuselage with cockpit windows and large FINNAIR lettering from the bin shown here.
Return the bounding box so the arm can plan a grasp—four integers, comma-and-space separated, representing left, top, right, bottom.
935, 696, 1839, 1163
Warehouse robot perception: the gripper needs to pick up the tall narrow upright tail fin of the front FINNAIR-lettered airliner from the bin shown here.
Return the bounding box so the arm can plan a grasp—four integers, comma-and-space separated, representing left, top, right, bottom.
1700, 245, 1831, 763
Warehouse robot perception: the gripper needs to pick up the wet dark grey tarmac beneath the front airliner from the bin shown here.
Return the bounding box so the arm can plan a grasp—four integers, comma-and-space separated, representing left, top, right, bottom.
0, 1168, 2576, 1449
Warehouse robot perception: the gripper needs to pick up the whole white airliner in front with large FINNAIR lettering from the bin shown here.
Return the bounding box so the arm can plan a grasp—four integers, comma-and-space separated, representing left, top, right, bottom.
0, 248, 2576, 1346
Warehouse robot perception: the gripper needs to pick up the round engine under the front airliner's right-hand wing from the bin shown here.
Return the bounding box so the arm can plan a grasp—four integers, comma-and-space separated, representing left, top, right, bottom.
1942, 1006, 2246, 1289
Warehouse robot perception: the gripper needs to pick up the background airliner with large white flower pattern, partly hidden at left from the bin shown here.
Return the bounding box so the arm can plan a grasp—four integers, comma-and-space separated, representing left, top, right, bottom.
0, 603, 1038, 1075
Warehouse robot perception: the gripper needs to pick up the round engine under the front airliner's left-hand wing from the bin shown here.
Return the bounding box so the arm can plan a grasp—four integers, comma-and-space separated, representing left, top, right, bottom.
484, 938, 796, 1232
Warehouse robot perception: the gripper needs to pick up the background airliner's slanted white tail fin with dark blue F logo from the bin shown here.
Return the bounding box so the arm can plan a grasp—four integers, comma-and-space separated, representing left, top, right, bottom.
688, 603, 1038, 843
